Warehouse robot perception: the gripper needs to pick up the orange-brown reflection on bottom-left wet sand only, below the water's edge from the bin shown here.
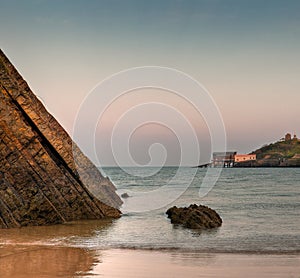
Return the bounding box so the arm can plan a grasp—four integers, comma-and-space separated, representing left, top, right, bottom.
0, 246, 99, 278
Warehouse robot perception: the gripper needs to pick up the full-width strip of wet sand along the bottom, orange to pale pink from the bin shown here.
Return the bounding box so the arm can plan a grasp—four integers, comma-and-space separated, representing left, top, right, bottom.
0, 245, 300, 278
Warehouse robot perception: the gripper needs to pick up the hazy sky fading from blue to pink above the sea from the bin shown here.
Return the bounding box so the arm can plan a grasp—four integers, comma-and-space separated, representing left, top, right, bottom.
0, 0, 300, 165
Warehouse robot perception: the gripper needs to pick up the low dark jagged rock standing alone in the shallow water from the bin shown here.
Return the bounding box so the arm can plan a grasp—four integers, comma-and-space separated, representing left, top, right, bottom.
166, 205, 222, 229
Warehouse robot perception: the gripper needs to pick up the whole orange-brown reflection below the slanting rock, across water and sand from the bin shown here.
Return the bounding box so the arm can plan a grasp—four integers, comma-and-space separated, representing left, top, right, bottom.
0, 219, 113, 278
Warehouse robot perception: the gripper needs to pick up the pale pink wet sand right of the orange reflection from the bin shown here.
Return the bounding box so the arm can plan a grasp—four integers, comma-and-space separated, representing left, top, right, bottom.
93, 250, 300, 278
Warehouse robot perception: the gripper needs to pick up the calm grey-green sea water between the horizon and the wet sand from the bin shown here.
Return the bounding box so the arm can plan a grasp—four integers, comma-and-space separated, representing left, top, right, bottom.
0, 167, 300, 253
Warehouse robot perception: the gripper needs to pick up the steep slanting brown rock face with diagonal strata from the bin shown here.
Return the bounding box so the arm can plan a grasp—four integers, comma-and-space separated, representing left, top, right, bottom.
0, 50, 122, 228
